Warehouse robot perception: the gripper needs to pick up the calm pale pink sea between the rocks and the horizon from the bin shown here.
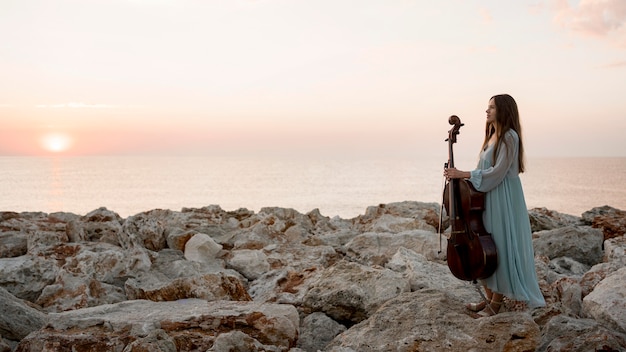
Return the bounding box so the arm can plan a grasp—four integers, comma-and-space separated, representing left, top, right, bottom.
0, 156, 626, 219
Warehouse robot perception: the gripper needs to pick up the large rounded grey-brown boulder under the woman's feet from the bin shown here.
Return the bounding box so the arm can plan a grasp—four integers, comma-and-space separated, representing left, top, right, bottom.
325, 289, 541, 352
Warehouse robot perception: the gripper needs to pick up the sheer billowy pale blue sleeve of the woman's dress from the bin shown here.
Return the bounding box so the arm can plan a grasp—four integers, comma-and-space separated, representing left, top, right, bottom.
469, 130, 519, 192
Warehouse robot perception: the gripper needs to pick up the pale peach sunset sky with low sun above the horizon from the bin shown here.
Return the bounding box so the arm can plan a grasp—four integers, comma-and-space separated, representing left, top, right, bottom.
0, 0, 626, 157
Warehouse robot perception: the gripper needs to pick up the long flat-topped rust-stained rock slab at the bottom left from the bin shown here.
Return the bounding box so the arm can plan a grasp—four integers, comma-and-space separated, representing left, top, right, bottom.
18, 299, 299, 352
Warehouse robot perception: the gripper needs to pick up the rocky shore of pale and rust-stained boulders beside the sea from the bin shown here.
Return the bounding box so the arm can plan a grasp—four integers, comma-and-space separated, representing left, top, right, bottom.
0, 202, 626, 352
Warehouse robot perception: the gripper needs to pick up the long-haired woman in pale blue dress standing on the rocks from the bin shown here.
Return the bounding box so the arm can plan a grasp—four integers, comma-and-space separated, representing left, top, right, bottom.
444, 94, 545, 316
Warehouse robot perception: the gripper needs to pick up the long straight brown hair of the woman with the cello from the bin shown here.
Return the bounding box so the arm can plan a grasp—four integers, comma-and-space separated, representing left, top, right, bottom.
483, 94, 525, 173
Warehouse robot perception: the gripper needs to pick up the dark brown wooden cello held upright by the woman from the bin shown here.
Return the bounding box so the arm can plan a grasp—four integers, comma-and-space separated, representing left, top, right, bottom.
440, 115, 498, 282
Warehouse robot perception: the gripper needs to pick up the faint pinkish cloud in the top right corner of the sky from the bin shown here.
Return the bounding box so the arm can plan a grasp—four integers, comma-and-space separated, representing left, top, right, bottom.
554, 0, 626, 49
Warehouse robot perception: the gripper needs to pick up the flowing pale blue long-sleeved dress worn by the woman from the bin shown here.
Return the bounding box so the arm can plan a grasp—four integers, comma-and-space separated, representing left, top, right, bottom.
469, 130, 545, 308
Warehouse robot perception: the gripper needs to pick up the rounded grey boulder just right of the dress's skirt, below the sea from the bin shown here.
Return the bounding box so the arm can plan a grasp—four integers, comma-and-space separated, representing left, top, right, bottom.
533, 226, 604, 266
